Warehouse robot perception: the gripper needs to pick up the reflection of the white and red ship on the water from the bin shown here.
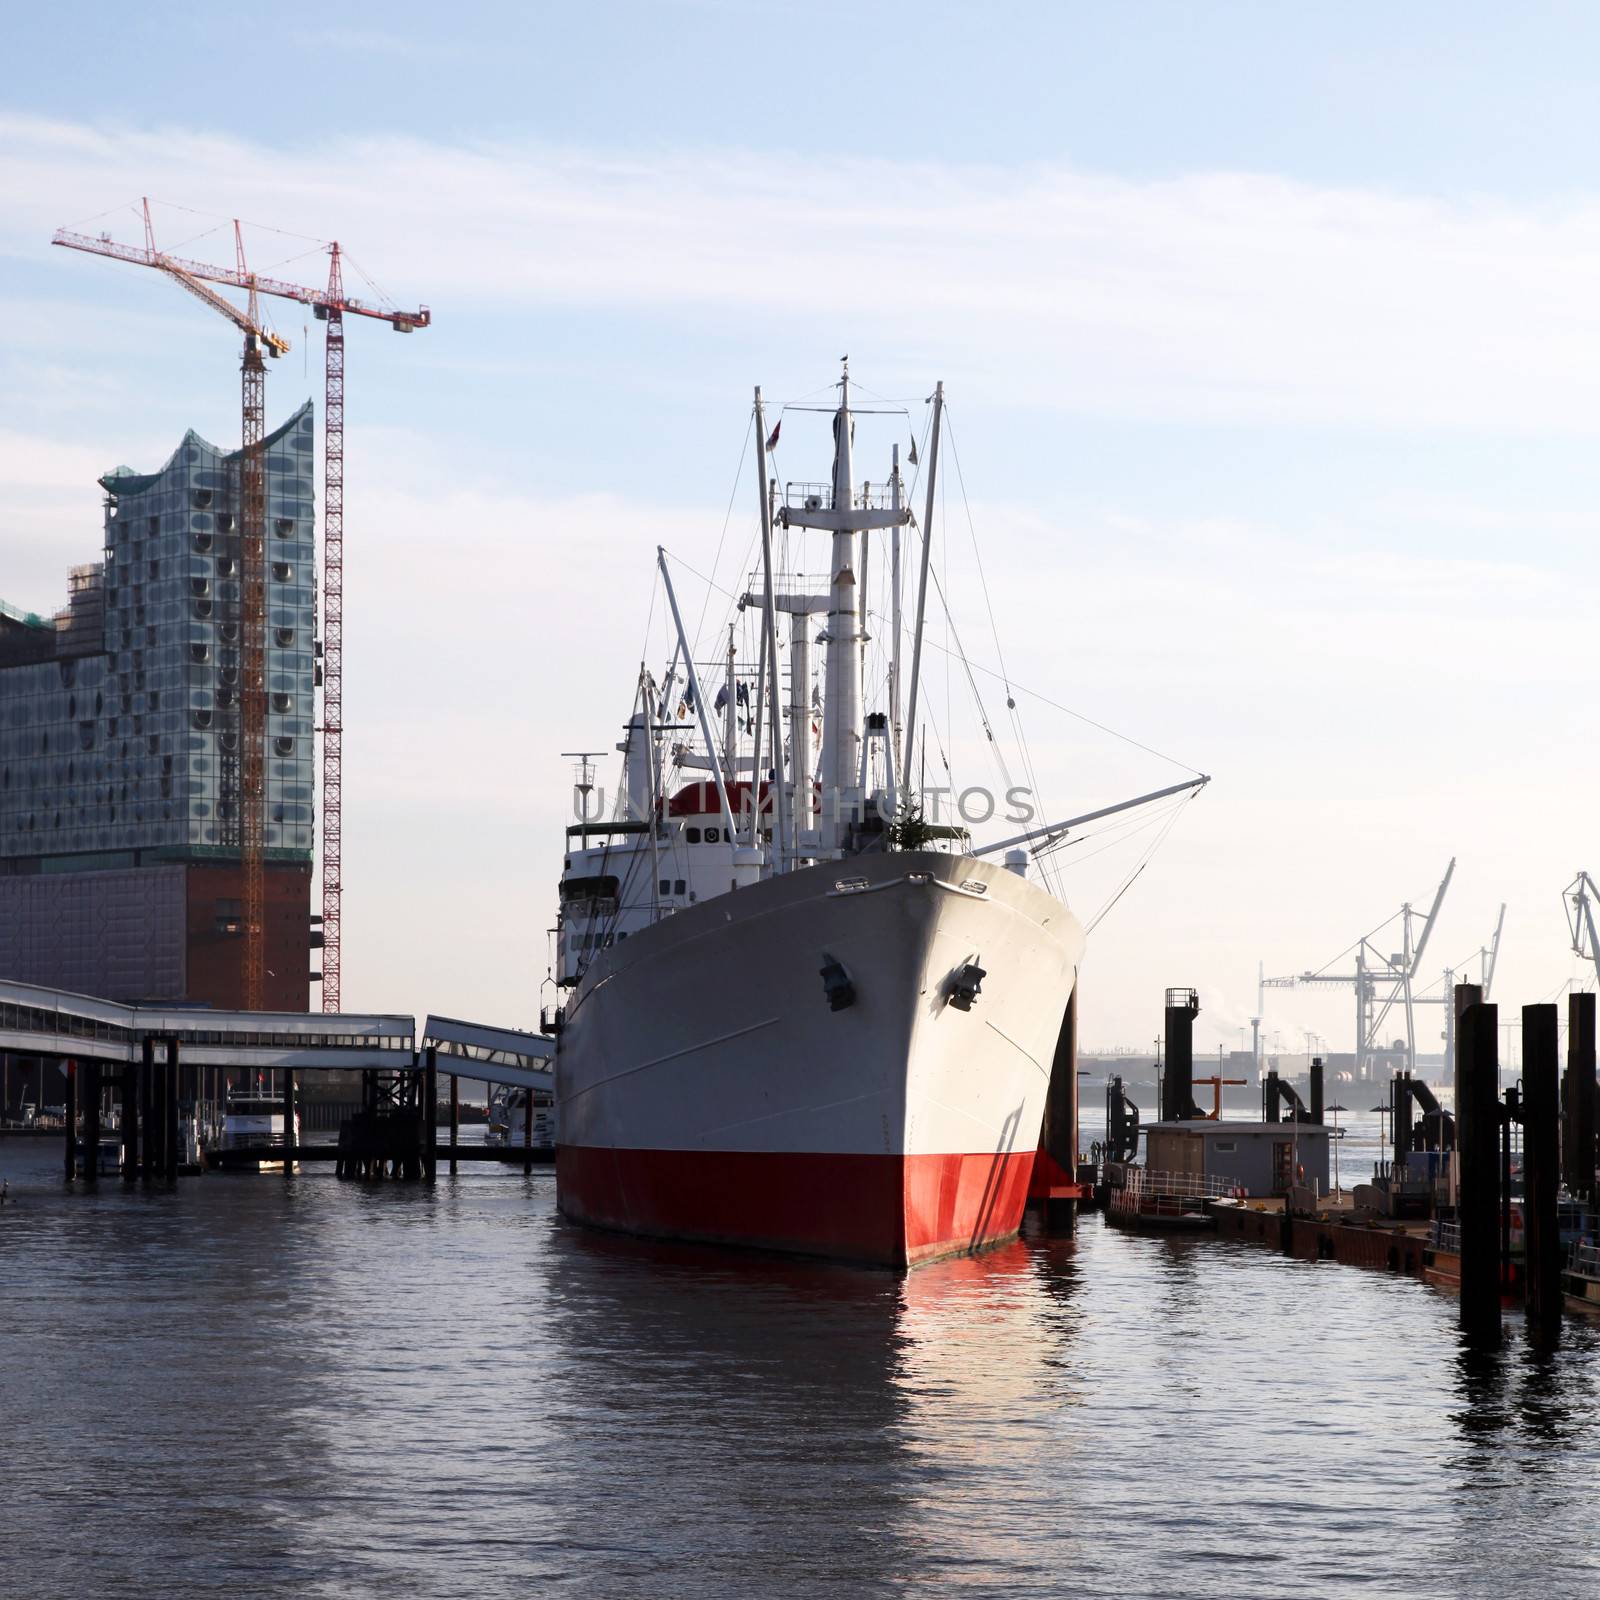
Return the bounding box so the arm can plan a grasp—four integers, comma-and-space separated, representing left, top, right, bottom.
531, 1230, 1080, 1594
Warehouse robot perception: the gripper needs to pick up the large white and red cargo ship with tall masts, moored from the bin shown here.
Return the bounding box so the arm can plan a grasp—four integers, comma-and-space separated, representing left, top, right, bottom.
554, 366, 1205, 1267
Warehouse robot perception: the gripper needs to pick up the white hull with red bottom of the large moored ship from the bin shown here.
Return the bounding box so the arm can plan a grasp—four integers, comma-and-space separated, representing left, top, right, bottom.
555, 853, 1083, 1266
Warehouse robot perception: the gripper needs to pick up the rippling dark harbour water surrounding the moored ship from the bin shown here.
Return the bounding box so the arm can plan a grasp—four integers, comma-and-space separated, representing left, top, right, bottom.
0, 1141, 1600, 1600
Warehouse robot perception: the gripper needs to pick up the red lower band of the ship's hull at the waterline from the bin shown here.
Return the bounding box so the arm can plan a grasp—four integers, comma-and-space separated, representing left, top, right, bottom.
555, 1144, 1034, 1266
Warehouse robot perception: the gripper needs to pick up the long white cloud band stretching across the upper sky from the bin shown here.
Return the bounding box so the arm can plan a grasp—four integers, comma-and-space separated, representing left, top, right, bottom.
9, 115, 1600, 432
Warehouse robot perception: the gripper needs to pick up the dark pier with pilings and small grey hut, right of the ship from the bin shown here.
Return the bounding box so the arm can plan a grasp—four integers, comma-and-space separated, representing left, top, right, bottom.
1093, 984, 1600, 1349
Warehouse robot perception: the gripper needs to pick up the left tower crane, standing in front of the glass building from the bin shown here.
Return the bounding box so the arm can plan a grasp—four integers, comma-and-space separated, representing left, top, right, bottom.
53, 203, 290, 1011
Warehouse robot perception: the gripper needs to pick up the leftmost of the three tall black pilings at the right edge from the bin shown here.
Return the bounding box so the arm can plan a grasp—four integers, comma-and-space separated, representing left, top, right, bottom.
1456, 984, 1501, 1344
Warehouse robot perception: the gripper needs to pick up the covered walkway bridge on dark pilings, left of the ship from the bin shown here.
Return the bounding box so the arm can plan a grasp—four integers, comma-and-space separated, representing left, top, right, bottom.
0, 981, 554, 1184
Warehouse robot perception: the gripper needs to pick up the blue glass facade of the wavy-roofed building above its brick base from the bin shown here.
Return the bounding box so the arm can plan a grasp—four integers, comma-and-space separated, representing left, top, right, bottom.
0, 402, 317, 872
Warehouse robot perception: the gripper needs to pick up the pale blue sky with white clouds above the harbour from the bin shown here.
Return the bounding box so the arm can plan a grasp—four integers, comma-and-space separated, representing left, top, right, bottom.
0, 0, 1600, 1050
